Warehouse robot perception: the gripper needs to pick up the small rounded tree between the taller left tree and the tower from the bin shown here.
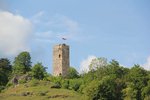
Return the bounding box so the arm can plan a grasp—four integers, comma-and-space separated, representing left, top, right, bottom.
32, 63, 46, 80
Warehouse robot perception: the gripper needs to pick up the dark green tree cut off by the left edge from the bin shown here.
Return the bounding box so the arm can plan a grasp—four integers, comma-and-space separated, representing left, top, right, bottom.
0, 58, 12, 86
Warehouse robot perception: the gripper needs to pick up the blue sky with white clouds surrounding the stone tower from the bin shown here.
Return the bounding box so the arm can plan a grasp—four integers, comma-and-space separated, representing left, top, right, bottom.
0, 0, 150, 73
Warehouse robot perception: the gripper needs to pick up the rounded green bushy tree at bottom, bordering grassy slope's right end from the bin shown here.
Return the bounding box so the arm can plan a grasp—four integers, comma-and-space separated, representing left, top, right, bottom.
84, 76, 119, 100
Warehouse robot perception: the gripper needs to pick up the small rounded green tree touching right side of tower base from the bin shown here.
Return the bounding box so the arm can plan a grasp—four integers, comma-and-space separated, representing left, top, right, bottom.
67, 67, 79, 79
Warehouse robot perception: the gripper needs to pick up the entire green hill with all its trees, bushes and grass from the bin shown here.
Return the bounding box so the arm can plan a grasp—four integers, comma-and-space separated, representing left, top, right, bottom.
0, 52, 150, 100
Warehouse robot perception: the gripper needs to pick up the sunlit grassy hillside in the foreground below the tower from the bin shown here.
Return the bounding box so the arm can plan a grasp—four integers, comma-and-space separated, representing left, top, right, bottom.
0, 81, 87, 100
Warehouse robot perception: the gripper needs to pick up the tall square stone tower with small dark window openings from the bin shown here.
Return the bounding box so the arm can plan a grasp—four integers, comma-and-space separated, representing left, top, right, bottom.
53, 44, 69, 76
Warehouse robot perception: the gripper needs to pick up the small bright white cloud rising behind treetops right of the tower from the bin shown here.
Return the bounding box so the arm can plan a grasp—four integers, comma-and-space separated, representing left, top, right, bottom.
79, 55, 96, 73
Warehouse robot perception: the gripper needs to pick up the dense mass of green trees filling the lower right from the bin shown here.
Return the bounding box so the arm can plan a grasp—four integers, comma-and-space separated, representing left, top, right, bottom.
79, 60, 150, 100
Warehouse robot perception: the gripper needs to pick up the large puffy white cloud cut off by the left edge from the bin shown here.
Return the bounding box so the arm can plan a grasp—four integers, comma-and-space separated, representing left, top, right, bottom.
0, 11, 32, 56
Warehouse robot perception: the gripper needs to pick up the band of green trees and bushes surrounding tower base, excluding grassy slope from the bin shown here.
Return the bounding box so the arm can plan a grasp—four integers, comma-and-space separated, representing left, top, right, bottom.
0, 52, 150, 100
